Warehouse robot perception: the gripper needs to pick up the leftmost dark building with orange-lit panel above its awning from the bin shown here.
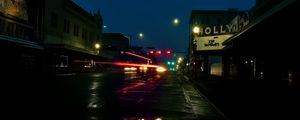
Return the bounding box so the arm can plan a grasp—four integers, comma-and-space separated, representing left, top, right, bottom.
0, 0, 44, 73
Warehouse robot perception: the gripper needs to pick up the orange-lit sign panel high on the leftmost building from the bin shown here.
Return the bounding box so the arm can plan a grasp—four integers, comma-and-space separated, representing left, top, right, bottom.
0, 0, 28, 21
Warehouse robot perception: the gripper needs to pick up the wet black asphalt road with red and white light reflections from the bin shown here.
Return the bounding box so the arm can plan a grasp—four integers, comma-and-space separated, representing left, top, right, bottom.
27, 71, 224, 120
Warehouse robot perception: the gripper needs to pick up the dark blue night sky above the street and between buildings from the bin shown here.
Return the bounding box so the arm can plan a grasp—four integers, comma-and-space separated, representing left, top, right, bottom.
74, 0, 255, 52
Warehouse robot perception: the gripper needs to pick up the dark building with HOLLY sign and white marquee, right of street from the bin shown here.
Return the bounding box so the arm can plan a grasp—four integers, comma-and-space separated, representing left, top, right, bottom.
188, 9, 242, 76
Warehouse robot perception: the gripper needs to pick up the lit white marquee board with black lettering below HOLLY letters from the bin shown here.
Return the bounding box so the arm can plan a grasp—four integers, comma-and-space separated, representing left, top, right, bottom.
195, 34, 233, 51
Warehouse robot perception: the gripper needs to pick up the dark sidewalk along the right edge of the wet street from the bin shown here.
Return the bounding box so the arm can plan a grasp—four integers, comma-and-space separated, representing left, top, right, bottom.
184, 71, 299, 120
